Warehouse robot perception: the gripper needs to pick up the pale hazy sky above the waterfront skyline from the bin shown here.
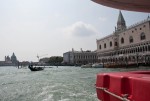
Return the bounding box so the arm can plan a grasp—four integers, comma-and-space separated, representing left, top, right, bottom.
0, 0, 148, 61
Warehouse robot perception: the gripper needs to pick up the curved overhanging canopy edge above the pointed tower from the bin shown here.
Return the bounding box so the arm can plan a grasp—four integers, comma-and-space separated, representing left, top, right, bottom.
92, 0, 150, 12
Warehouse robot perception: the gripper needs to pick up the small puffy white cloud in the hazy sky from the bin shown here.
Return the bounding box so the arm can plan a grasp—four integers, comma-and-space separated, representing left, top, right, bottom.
63, 21, 98, 37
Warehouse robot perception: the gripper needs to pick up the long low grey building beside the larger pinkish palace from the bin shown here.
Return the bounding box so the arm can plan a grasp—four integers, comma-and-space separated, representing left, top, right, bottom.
63, 49, 97, 65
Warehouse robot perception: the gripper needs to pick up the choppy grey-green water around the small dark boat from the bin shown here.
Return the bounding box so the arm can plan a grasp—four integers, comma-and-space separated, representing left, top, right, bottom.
0, 67, 149, 101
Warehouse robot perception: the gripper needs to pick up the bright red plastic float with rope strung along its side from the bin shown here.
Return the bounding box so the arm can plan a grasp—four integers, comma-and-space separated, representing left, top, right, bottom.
96, 71, 150, 101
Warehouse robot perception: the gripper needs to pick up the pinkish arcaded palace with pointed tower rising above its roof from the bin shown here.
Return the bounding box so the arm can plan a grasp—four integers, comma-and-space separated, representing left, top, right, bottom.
96, 11, 150, 64
